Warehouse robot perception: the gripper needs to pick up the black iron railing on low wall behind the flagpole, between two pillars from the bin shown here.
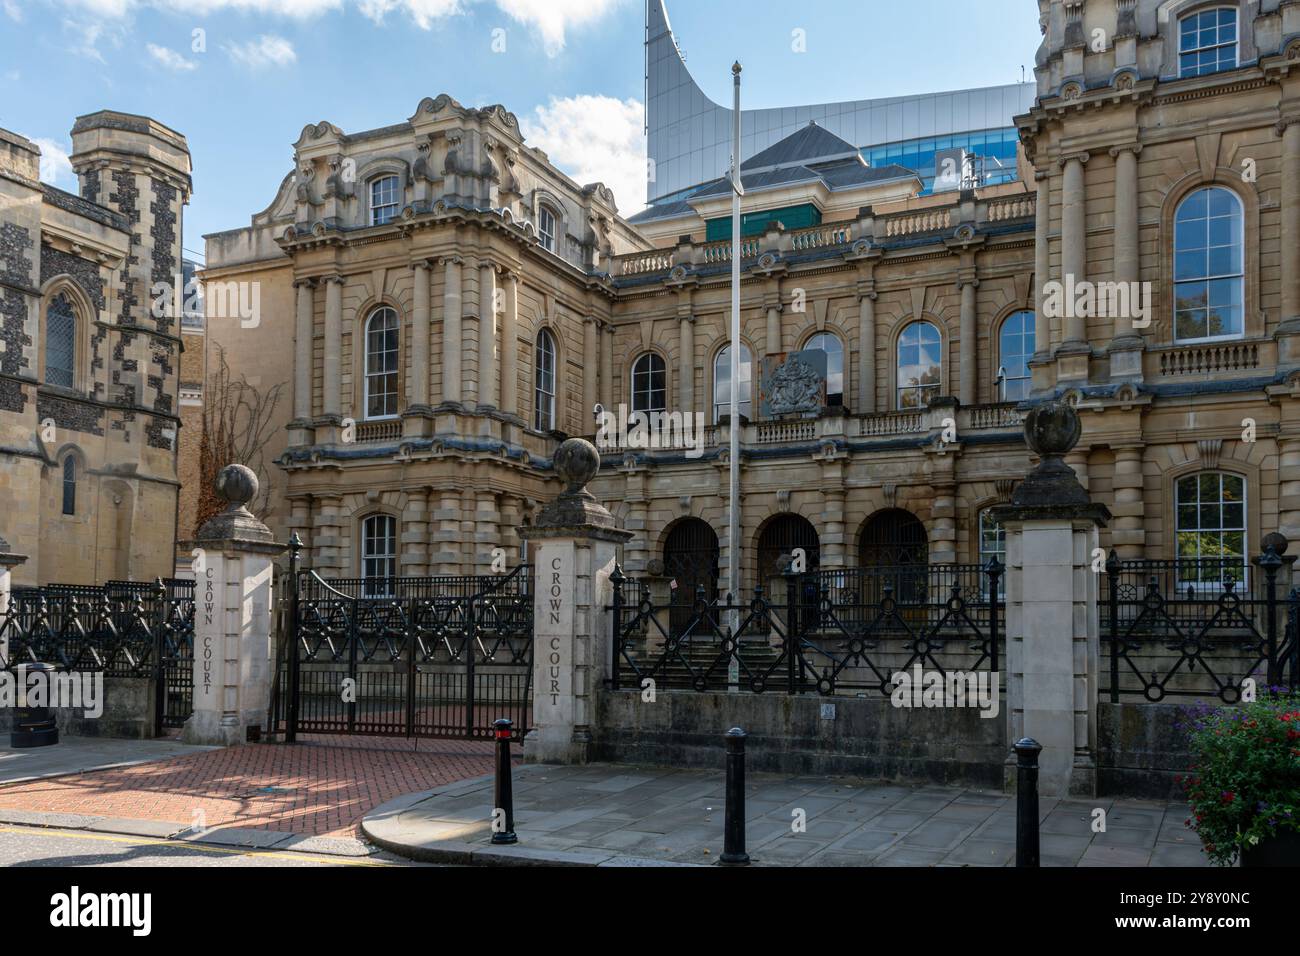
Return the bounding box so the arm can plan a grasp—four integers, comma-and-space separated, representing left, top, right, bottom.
610, 561, 1005, 696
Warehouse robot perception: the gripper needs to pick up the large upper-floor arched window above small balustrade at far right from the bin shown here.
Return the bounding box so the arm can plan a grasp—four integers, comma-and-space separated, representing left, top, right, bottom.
1174, 186, 1245, 342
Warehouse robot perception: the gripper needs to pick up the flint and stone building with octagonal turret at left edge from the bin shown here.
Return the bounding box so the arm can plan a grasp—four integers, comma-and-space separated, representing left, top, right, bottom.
0, 111, 191, 584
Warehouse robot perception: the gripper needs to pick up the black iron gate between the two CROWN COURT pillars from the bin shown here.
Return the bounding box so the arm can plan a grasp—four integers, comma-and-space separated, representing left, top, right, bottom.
270, 554, 533, 743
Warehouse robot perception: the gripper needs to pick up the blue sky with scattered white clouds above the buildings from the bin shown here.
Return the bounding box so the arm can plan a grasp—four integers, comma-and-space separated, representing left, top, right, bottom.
0, 0, 1039, 260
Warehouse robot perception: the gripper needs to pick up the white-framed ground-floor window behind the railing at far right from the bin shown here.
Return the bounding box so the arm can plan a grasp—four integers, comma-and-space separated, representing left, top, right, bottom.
1175, 472, 1248, 588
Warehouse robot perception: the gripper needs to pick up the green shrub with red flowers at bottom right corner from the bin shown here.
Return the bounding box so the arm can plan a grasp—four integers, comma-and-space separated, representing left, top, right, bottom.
1180, 688, 1300, 866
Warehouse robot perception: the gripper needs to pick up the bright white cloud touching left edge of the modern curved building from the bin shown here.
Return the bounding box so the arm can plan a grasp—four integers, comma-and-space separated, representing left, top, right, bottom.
520, 96, 646, 216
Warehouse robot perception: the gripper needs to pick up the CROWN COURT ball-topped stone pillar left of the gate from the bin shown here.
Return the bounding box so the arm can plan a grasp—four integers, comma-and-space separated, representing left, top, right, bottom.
182, 464, 286, 747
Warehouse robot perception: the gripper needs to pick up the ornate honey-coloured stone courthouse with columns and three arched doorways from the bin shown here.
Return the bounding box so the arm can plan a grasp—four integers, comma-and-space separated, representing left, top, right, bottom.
195, 0, 1300, 598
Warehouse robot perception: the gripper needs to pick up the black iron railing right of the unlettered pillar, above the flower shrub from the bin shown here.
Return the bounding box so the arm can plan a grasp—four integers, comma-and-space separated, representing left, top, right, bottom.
1099, 548, 1300, 704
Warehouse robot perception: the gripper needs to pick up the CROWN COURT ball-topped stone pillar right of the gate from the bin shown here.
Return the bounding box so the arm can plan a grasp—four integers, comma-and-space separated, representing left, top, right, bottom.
519, 438, 633, 763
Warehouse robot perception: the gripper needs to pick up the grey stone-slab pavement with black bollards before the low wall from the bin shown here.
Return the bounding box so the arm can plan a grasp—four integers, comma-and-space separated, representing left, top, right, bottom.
361, 765, 1204, 868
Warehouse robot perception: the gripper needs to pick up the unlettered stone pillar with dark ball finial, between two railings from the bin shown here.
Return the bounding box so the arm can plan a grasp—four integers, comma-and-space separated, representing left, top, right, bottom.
993, 402, 1110, 796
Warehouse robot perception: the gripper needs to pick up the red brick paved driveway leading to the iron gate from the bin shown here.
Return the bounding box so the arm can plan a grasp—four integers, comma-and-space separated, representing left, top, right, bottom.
0, 737, 493, 836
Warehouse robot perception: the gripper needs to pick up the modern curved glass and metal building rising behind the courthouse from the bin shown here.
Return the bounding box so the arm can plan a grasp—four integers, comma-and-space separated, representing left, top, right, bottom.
646, 0, 1035, 204
